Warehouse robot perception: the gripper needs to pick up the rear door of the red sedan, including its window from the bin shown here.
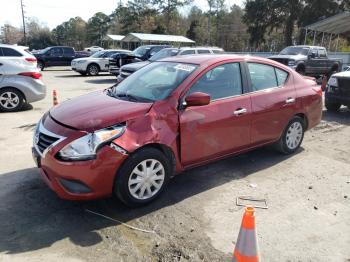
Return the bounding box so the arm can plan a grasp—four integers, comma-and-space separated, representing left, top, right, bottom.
246, 62, 296, 146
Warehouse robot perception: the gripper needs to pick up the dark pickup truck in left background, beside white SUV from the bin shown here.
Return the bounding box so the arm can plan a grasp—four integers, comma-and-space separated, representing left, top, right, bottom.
33, 46, 90, 70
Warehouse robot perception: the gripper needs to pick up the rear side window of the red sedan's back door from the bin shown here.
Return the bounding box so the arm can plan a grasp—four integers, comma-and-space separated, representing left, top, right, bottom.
248, 63, 288, 92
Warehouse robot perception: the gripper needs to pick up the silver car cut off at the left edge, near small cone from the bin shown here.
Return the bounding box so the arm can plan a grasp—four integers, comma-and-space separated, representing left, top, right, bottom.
0, 58, 46, 112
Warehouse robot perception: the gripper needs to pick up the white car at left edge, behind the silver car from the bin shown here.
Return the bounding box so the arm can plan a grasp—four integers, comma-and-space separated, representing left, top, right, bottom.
0, 44, 37, 67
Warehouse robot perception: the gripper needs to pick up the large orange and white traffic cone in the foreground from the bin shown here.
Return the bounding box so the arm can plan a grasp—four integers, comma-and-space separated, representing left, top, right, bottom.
232, 207, 259, 262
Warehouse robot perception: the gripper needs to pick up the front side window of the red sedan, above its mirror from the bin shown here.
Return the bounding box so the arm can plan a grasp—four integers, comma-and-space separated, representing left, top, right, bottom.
188, 63, 242, 100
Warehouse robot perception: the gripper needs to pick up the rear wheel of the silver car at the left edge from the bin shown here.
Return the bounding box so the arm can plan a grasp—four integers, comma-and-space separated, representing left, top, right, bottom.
0, 87, 25, 112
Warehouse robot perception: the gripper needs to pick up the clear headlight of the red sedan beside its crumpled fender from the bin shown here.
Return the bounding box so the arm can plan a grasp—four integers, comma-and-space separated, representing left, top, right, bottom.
59, 125, 125, 160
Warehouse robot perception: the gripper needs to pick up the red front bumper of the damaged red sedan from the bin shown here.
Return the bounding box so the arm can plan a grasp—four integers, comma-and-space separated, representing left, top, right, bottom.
32, 117, 127, 200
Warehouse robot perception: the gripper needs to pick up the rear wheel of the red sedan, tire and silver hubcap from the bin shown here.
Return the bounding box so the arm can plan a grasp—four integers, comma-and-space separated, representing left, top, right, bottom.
276, 116, 305, 155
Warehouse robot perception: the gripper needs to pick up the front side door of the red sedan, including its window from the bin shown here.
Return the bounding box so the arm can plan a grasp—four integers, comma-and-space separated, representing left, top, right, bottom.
179, 63, 252, 166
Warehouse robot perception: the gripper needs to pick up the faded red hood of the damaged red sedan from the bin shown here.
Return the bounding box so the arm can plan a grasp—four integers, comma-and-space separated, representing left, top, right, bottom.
50, 91, 152, 132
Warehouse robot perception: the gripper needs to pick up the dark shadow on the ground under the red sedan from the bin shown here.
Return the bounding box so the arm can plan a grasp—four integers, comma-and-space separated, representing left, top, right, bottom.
0, 147, 303, 254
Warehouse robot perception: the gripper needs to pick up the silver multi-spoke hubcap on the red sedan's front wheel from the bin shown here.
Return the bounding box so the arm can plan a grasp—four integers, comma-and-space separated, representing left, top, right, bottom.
128, 159, 165, 200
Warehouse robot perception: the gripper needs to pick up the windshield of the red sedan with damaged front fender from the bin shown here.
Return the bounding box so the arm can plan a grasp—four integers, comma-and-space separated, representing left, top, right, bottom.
108, 62, 197, 102
